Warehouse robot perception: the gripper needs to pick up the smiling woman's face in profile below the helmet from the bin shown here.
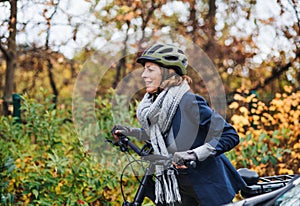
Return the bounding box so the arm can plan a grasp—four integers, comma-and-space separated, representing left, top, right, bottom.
142, 62, 162, 93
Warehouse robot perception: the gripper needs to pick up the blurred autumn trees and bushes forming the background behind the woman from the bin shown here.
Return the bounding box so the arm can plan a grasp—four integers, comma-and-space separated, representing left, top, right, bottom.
0, 0, 300, 205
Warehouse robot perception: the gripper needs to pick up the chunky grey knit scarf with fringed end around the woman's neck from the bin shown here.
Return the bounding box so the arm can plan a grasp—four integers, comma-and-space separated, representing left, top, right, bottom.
137, 81, 190, 204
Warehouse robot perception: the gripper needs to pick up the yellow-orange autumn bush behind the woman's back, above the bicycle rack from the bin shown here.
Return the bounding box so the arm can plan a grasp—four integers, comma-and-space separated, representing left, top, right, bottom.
229, 86, 300, 175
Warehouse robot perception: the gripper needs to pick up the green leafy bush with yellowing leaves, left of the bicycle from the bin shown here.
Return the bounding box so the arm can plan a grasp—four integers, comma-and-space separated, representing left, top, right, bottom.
0, 92, 140, 205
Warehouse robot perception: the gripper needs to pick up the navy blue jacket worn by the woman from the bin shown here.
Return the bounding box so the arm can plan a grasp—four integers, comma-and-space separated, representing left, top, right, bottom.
166, 92, 245, 206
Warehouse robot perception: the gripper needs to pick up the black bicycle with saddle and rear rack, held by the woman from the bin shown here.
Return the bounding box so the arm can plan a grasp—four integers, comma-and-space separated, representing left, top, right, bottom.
107, 131, 300, 206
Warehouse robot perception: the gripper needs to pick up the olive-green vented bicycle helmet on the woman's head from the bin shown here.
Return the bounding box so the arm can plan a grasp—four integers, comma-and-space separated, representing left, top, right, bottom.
137, 44, 188, 76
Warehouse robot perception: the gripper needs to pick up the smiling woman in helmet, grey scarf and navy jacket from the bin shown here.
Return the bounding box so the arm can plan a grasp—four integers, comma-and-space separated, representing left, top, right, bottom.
115, 44, 245, 206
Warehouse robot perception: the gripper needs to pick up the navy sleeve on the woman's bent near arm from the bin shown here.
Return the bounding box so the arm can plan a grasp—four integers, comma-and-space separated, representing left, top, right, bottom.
186, 95, 239, 155
